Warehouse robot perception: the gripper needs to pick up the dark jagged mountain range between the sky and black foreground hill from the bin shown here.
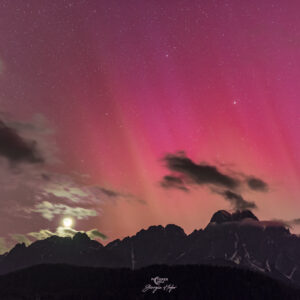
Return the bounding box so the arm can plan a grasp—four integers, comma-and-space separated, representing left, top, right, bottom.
0, 210, 300, 286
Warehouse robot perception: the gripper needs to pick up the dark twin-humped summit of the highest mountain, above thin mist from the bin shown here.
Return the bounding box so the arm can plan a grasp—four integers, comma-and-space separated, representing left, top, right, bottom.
210, 209, 258, 224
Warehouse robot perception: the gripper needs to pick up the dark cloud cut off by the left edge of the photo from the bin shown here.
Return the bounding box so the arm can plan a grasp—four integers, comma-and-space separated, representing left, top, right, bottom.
0, 120, 44, 163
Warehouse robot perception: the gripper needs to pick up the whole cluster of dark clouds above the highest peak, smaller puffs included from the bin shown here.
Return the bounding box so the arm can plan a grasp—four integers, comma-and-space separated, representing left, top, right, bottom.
160, 151, 268, 210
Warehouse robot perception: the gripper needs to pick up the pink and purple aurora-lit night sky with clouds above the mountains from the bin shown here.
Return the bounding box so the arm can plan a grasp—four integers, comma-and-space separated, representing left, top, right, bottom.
0, 0, 300, 251
